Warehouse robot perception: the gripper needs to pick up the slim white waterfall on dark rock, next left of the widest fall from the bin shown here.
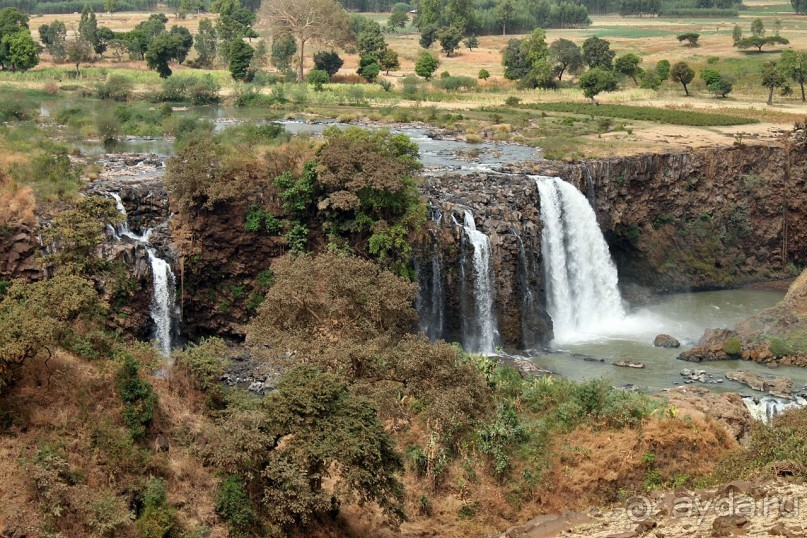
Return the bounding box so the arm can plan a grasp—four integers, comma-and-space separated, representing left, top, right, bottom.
460, 211, 498, 353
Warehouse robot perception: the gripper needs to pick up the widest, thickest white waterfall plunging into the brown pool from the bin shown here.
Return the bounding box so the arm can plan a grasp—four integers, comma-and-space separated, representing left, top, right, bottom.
535, 176, 625, 343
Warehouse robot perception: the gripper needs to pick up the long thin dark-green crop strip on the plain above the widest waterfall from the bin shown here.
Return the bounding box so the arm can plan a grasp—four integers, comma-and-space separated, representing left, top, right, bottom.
525, 103, 758, 127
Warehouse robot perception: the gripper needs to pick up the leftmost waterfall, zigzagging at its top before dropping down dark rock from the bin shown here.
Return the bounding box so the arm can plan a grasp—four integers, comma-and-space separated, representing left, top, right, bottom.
109, 192, 179, 356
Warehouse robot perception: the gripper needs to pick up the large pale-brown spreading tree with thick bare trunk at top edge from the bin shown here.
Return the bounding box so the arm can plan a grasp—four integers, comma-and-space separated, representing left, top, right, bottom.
261, 0, 350, 82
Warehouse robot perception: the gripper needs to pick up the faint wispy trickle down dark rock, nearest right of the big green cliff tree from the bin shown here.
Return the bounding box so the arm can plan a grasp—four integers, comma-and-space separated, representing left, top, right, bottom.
415, 209, 445, 342
